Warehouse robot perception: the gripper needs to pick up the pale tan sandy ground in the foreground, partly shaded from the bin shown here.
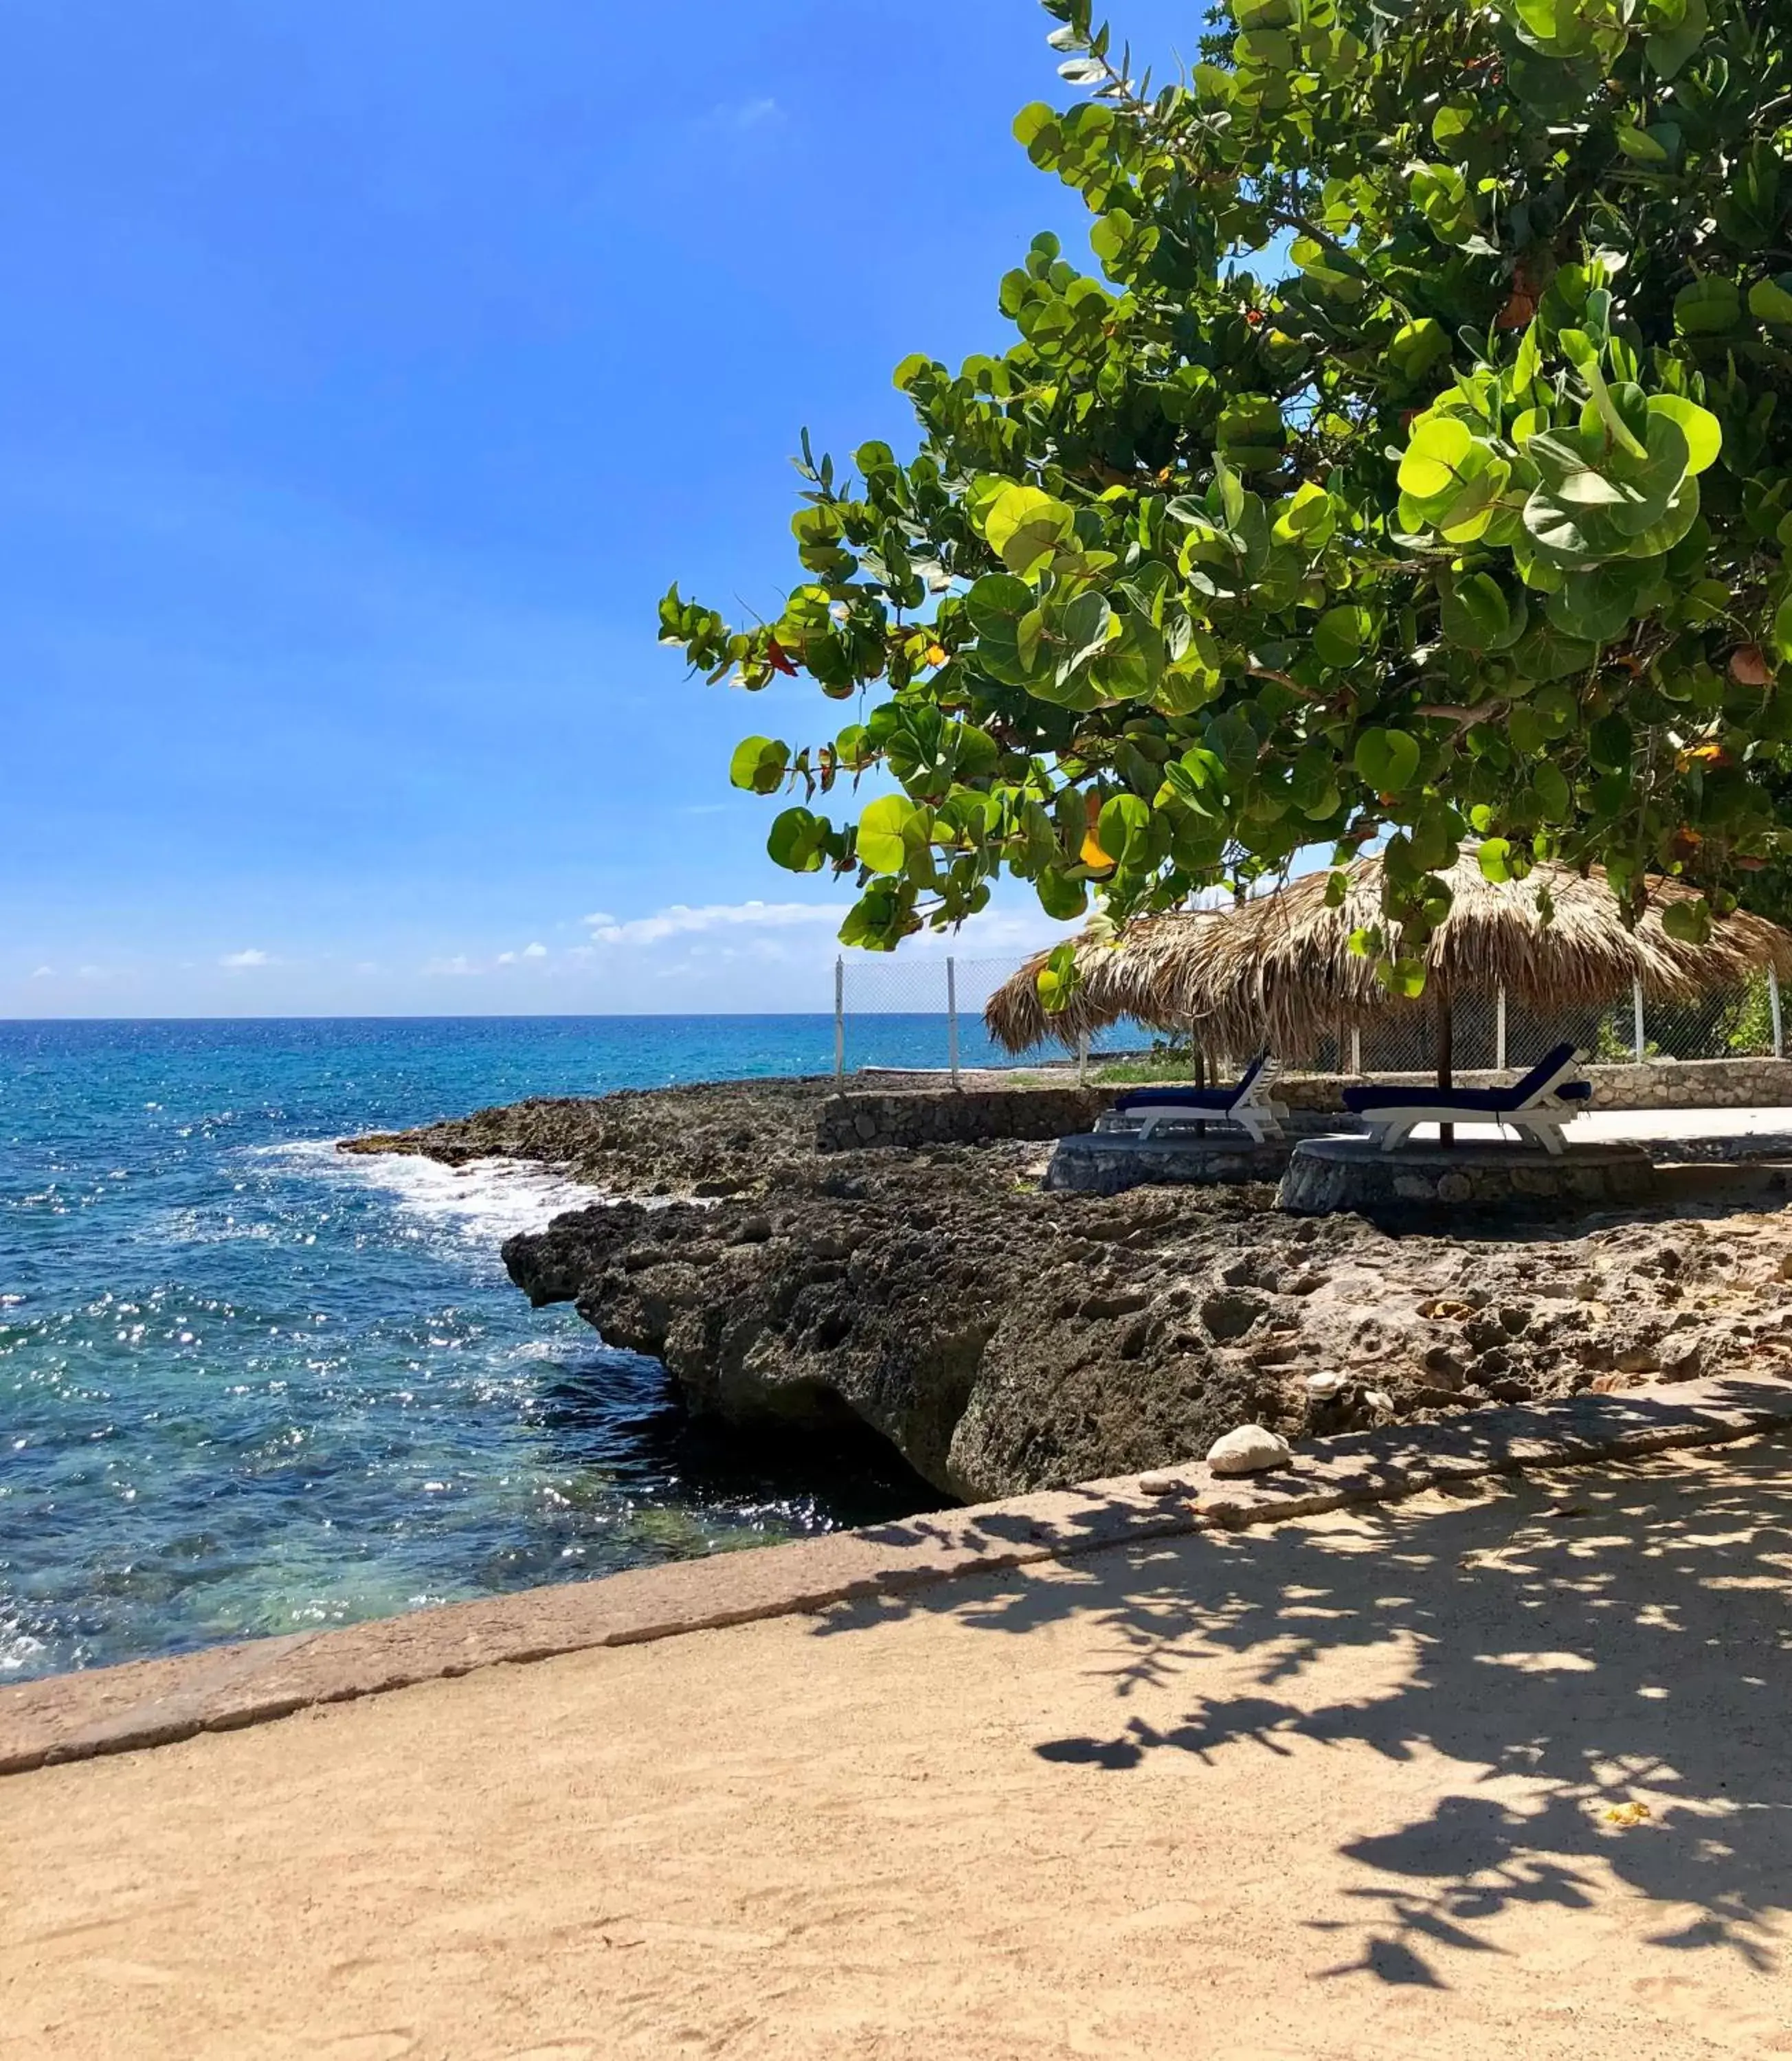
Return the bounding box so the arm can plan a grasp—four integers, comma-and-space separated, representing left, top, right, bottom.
0, 1441, 1792, 2061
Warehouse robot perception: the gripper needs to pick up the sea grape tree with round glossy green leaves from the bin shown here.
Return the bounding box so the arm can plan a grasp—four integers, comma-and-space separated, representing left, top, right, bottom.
662, 0, 1792, 991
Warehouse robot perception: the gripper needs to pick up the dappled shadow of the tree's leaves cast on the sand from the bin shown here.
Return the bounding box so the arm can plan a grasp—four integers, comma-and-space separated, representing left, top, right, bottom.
818, 1434, 1792, 1987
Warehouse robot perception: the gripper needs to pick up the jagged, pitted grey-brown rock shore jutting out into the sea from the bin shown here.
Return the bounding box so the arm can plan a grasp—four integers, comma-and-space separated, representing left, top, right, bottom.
346, 1080, 1792, 1500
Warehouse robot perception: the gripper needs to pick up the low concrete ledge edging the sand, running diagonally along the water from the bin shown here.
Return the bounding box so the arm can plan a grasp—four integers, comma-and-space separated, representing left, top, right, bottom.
0, 1379, 1792, 1775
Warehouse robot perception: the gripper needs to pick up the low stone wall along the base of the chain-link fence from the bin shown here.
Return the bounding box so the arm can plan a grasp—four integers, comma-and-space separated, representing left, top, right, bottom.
814, 1059, 1792, 1152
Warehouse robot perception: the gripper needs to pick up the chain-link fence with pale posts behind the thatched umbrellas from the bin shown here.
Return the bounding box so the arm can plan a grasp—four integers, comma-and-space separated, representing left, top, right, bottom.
835, 952, 1784, 1076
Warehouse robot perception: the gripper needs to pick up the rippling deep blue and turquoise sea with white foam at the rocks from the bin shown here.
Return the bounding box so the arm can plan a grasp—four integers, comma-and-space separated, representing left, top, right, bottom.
0, 1016, 1022, 1680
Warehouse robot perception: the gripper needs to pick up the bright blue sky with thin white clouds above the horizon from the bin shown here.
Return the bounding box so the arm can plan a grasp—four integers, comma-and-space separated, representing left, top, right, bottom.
0, 0, 1198, 1016
